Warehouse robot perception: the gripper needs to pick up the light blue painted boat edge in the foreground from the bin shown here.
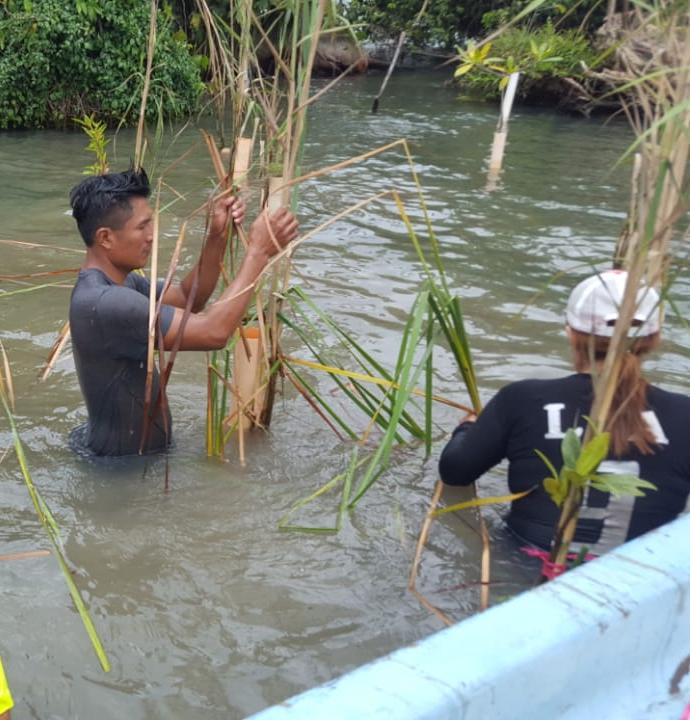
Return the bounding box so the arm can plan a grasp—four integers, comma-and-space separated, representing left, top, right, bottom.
247, 515, 690, 720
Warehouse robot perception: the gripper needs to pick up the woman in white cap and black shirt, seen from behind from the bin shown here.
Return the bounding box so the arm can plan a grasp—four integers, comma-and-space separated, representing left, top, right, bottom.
439, 270, 690, 554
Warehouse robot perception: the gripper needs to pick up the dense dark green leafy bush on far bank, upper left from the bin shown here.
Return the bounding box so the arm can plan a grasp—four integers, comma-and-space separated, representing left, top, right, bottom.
0, 0, 203, 128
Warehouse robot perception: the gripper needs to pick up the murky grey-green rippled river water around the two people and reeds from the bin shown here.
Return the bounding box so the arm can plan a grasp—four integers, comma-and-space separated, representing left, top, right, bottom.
0, 69, 690, 720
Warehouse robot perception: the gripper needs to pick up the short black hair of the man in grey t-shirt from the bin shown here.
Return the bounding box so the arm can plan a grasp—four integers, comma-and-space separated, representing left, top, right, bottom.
69, 168, 151, 247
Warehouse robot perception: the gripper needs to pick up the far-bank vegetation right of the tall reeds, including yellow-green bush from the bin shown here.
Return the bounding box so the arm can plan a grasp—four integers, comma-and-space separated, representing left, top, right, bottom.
344, 0, 668, 115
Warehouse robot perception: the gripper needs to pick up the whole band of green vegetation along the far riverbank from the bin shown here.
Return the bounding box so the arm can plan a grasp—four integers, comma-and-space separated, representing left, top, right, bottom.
0, 0, 652, 129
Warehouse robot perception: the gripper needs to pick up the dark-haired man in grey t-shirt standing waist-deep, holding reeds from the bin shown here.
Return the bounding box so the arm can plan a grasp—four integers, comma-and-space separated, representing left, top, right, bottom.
69, 170, 298, 455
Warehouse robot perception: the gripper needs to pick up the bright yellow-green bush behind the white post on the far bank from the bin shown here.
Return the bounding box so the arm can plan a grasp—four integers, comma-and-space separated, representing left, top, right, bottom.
456, 22, 596, 97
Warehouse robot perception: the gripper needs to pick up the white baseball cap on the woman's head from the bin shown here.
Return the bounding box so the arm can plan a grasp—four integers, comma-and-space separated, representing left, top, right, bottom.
565, 270, 661, 337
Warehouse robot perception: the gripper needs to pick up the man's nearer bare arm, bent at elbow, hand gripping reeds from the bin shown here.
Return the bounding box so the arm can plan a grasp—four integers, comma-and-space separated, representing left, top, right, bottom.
164, 208, 298, 350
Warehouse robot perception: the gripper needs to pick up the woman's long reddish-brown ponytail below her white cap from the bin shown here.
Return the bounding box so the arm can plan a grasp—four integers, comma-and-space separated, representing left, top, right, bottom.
570, 328, 659, 457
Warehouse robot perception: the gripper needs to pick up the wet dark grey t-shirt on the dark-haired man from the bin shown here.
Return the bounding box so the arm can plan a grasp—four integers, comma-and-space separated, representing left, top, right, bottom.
69, 268, 174, 455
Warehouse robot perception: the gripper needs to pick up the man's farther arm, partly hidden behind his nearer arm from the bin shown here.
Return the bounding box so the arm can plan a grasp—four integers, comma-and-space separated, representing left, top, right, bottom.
163, 197, 246, 313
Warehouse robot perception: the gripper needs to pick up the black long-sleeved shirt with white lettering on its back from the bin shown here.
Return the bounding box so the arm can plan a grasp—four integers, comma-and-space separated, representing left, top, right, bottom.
439, 373, 690, 553
